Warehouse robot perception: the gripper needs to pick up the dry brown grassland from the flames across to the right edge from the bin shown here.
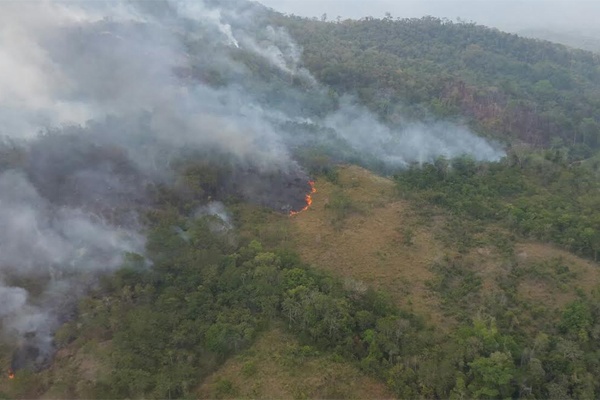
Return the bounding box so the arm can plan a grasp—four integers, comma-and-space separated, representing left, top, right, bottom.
291, 166, 600, 329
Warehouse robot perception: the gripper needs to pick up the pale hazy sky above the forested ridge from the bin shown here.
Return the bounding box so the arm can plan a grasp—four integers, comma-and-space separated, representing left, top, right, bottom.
259, 0, 600, 33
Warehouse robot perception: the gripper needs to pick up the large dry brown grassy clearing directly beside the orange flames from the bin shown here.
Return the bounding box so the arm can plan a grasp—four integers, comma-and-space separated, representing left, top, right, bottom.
292, 166, 443, 321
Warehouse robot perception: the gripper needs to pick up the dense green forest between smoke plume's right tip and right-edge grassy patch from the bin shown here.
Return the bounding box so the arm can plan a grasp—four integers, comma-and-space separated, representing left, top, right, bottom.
396, 151, 600, 261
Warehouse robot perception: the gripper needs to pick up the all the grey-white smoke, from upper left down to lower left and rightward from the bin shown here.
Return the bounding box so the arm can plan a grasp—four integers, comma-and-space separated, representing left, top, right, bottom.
0, 0, 503, 368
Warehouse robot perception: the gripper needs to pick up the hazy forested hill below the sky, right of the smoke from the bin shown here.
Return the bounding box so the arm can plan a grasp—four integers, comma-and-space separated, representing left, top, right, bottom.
274, 15, 600, 157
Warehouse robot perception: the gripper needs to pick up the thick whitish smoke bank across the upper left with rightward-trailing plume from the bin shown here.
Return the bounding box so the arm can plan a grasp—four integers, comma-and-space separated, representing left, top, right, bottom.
0, 1, 502, 168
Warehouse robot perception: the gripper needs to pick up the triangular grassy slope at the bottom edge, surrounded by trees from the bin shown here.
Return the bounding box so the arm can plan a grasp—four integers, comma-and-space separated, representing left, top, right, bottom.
198, 327, 392, 399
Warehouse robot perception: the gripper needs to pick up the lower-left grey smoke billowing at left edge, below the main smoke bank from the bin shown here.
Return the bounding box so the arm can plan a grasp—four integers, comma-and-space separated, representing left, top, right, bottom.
0, 171, 144, 364
